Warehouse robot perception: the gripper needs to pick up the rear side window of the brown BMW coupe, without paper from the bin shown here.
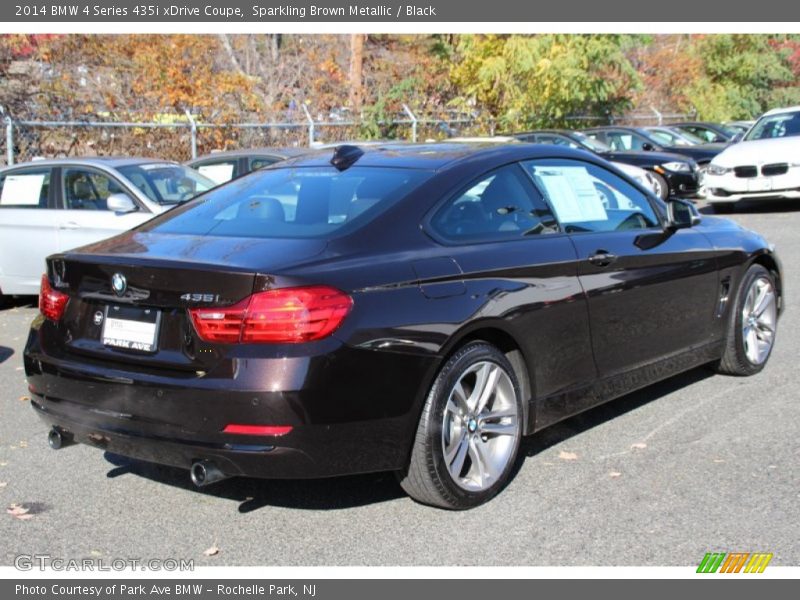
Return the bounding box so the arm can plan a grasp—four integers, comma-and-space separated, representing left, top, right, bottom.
430, 164, 558, 242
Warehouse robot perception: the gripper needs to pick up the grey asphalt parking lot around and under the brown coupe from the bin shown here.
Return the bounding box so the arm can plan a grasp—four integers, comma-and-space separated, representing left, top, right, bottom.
0, 203, 800, 566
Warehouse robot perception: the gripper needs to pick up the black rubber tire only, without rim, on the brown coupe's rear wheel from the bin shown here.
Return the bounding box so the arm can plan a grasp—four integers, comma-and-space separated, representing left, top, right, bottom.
398, 342, 524, 510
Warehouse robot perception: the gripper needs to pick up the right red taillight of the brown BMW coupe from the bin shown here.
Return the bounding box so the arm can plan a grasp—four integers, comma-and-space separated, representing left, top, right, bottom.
189, 286, 353, 344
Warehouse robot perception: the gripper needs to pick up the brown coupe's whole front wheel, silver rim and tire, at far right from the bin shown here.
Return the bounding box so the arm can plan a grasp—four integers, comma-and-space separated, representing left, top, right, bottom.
717, 265, 778, 375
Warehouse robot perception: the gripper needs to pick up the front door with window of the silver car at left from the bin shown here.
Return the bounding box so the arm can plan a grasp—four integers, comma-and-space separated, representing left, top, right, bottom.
57, 166, 153, 252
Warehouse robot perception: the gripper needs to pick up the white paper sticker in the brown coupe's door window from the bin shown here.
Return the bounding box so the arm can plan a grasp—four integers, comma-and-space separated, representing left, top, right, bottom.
535, 166, 608, 223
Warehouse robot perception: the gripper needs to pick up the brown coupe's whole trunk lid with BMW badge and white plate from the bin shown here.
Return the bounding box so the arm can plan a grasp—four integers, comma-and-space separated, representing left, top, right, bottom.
48, 232, 326, 371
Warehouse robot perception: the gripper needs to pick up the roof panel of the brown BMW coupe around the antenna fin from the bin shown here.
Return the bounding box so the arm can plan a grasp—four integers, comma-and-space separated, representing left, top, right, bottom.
269, 142, 590, 170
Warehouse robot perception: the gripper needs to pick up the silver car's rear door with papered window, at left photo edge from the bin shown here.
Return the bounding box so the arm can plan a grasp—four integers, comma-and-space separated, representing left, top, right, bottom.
0, 167, 58, 294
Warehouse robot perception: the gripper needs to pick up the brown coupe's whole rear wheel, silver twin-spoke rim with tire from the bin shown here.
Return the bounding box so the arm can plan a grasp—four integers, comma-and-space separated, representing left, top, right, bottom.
399, 342, 523, 510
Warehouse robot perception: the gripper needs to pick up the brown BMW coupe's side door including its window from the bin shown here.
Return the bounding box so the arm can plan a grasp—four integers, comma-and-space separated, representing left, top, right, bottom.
525, 159, 720, 376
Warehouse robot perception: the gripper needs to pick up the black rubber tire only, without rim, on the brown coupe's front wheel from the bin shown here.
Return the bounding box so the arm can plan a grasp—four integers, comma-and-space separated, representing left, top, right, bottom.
713, 265, 777, 376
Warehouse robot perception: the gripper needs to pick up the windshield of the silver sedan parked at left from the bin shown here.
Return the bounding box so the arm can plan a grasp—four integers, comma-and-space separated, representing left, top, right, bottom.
117, 162, 217, 204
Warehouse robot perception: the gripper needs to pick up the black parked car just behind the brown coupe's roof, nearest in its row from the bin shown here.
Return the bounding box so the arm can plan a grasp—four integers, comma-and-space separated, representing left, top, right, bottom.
515, 129, 703, 200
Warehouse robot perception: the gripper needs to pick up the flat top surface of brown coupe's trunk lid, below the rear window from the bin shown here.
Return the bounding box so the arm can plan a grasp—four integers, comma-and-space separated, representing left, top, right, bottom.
58, 230, 327, 273
